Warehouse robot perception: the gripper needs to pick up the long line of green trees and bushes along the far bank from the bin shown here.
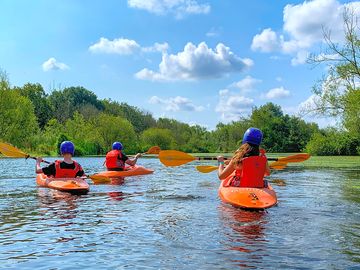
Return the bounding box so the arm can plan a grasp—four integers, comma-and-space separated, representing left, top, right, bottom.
0, 71, 319, 155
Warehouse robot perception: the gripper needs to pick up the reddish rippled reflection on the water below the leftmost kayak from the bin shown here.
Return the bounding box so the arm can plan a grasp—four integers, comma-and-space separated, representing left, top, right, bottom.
38, 188, 79, 220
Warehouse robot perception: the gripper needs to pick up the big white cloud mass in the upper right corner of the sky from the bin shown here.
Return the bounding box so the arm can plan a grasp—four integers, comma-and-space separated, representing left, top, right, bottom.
251, 0, 360, 65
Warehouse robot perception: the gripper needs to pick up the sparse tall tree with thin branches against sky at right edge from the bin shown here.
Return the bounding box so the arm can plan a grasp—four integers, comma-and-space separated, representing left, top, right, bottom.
307, 9, 360, 138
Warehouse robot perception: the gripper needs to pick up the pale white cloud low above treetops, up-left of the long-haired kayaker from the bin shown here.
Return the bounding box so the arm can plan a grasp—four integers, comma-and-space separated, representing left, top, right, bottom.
215, 89, 254, 122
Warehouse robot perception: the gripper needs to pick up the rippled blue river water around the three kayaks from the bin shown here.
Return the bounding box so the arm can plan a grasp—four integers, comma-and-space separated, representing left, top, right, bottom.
0, 158, 360, 269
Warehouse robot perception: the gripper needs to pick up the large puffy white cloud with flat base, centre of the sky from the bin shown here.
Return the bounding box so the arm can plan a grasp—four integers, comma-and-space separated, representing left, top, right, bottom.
135, 42, 253, 81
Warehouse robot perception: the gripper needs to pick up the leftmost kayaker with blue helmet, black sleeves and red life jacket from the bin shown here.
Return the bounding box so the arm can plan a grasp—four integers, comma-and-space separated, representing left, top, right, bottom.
35, 141, 85, 178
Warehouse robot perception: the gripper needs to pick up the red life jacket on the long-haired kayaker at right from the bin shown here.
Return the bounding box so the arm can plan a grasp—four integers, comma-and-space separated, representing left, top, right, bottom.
230, 155, 267, 188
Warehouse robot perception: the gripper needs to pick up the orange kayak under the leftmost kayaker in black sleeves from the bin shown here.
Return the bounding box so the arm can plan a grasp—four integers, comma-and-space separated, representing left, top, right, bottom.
36, 173, 90, 194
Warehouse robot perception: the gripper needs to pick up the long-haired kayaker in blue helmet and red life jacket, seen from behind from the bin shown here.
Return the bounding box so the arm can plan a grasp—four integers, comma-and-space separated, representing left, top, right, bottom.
217, 128, 270, 188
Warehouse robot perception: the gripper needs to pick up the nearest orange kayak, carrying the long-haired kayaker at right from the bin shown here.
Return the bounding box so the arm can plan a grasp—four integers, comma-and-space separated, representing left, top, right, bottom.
219, 175, 277, 209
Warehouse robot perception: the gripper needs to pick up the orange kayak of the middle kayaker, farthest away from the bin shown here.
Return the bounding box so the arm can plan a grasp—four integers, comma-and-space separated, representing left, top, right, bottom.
91, 165, 154, 183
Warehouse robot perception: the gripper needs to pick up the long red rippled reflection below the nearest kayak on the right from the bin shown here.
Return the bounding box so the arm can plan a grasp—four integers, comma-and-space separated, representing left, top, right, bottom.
220, 204, 268, 268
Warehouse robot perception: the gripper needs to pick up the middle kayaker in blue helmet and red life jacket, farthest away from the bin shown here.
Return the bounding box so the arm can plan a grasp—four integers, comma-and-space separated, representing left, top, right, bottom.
105, 142, 141, 171
